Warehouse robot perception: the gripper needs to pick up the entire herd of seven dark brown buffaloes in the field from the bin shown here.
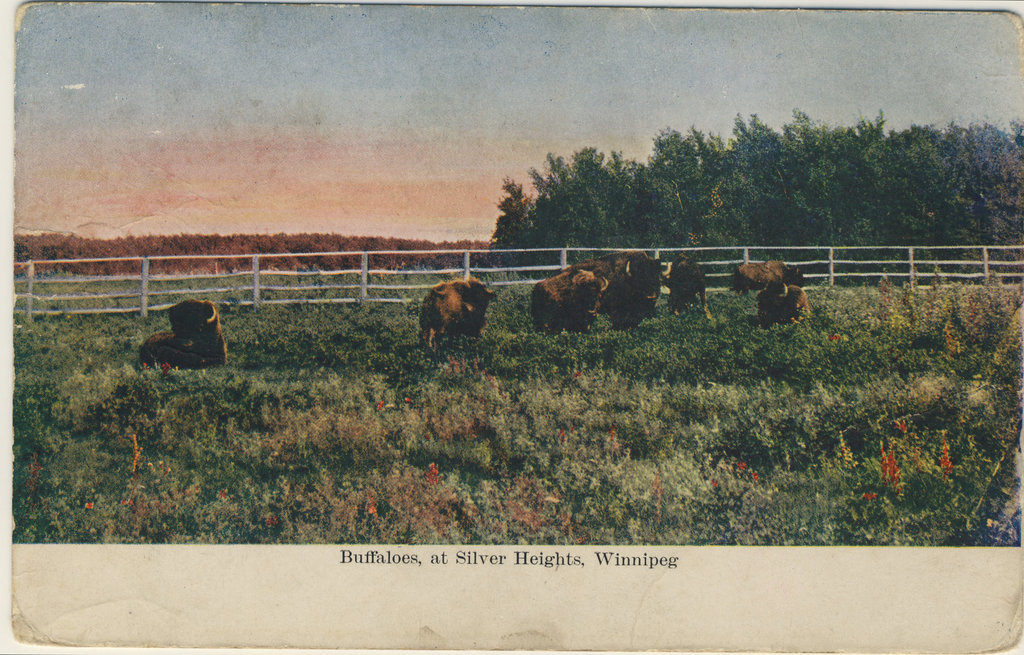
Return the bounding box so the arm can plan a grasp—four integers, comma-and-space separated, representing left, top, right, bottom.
139, 251, 810, 368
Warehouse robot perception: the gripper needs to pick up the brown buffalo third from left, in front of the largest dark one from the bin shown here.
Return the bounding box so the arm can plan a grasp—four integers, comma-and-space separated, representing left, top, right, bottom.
529, 269, 608, 334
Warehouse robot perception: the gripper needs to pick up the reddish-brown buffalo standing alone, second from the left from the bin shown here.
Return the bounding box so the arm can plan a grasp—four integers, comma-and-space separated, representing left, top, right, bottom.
420, 277, 495, 349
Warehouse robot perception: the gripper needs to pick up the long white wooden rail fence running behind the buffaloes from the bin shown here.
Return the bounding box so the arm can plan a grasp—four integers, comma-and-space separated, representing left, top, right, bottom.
14, 246, 1024, 319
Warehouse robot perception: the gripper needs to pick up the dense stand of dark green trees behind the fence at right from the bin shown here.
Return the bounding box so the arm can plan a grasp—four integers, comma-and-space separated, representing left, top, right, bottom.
490, 111, 1024, 248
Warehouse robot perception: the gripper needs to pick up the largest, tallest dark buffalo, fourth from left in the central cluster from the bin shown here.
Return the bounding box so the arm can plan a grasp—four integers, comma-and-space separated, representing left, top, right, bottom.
568, 251, 662, 330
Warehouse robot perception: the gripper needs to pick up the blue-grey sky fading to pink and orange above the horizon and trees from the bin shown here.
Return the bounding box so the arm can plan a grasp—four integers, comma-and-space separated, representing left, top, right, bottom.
14, 3, 1024, 241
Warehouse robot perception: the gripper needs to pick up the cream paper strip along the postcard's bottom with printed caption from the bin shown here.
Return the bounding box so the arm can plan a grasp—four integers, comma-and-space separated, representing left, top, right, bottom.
4, 2, 1024, 652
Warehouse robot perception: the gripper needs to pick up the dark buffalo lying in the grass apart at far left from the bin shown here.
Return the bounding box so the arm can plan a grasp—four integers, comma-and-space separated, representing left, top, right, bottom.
138, 300, 227, 368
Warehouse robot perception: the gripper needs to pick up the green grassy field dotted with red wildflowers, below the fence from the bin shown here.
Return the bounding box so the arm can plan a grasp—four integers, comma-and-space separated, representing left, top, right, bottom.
13, 283, 1021, 545
